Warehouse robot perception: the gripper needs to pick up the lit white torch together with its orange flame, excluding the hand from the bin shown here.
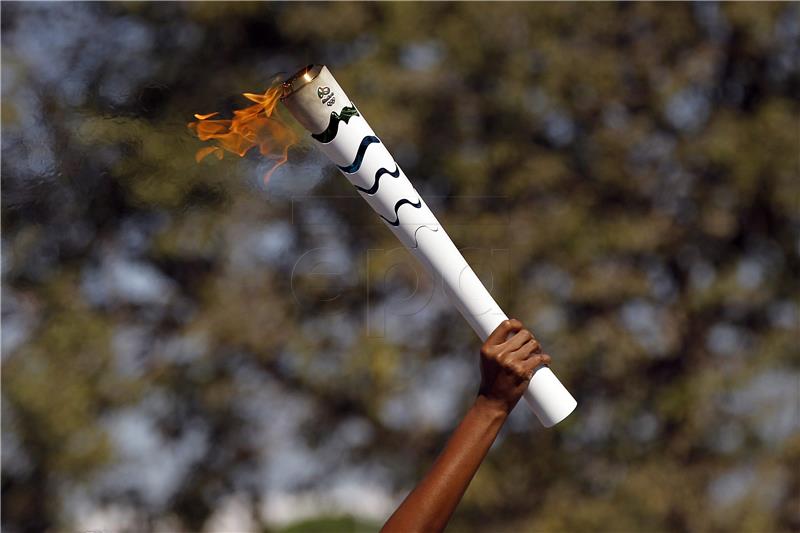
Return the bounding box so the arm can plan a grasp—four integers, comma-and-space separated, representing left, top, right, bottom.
189, 65, 577, 427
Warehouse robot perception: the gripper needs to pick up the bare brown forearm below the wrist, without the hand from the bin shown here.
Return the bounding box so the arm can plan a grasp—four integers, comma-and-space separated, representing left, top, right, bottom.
382, 396, 508, 533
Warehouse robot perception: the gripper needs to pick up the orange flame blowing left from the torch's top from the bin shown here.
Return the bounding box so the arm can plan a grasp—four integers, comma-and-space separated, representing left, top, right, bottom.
188, 85, 297, 183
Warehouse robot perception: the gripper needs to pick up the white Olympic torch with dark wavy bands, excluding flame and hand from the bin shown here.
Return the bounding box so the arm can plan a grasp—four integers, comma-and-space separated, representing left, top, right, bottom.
281, 65, 577, 427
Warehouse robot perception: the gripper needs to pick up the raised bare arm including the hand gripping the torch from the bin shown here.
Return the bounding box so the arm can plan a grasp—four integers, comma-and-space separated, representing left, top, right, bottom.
381, 320, 550, 533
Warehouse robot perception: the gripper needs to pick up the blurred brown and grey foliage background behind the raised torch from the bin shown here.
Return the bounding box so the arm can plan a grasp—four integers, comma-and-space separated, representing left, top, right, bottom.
2, 2, 800, 533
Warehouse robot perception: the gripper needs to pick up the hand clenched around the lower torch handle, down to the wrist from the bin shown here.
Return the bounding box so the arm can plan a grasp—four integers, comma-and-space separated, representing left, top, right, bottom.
478, 319, 550, 414
